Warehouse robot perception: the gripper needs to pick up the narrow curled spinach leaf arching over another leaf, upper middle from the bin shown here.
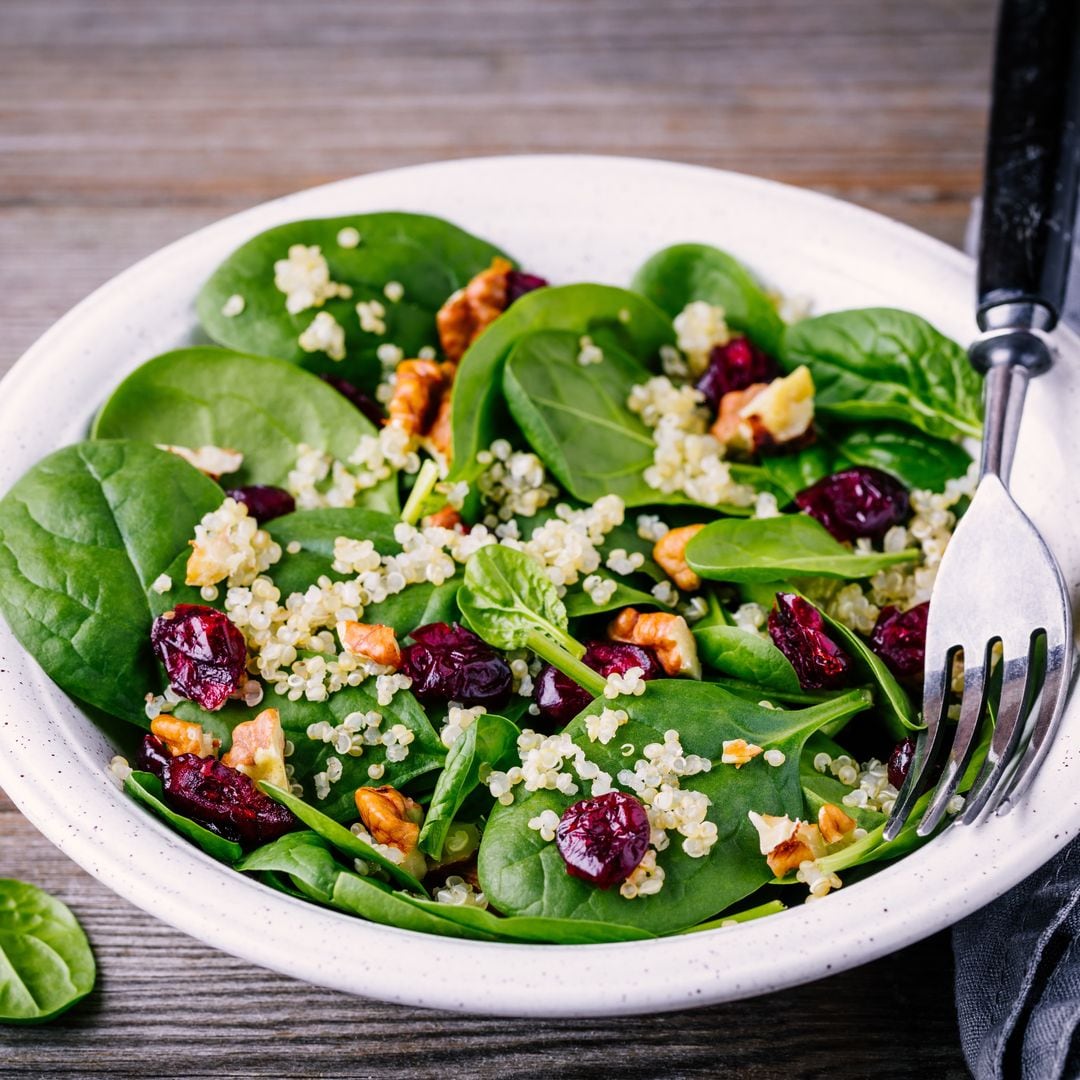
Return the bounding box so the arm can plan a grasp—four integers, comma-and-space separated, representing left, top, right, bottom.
449, 285, 675, 481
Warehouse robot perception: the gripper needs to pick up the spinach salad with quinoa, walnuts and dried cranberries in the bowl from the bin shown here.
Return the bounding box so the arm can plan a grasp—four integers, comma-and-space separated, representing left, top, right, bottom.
0, 213, 985, 943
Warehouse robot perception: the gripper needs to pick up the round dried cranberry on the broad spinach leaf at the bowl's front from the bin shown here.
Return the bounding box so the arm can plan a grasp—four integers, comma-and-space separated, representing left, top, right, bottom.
555, 792, 649, 889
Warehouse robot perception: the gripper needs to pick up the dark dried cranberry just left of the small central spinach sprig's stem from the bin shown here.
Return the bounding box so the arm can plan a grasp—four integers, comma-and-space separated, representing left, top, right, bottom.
402, 622, 513, 708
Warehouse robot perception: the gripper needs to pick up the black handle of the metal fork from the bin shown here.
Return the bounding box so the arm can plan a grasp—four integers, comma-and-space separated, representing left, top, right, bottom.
978, 0, 1080, 330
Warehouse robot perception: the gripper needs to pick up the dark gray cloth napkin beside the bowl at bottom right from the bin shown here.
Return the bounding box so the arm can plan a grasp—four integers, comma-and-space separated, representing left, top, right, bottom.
953, 214, 1080, 1080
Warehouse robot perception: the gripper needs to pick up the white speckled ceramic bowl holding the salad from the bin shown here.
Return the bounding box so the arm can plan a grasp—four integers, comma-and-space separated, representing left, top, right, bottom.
0, 157, 1080, 1016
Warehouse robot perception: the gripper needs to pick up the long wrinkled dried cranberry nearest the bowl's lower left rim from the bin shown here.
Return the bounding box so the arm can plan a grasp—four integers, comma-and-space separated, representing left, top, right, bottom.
162, 754, 299, 848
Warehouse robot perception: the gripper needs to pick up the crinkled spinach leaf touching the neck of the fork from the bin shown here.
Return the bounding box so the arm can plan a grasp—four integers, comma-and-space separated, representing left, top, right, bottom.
781, 308, 983, 438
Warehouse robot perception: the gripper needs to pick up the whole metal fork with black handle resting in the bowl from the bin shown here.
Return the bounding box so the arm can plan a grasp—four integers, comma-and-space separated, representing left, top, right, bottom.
885, 0, 1080, 840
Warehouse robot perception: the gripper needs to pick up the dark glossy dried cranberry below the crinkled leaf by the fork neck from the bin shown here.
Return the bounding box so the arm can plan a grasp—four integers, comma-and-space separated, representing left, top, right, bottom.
795, 465, 910, 540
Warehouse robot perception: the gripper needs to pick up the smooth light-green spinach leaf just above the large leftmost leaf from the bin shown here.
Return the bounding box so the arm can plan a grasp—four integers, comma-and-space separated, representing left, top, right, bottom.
93, 347, 399, 514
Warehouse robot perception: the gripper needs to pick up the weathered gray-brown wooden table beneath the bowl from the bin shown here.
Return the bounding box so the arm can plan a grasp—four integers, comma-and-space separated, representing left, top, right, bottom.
0, 0, 993, 1080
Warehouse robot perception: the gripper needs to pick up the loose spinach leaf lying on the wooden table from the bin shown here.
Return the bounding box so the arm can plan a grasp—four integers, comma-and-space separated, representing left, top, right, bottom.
0, 878, 97, 1024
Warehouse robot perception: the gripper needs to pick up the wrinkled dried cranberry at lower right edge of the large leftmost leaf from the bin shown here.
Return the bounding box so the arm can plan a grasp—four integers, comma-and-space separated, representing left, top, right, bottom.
150, 604, 247, 712
